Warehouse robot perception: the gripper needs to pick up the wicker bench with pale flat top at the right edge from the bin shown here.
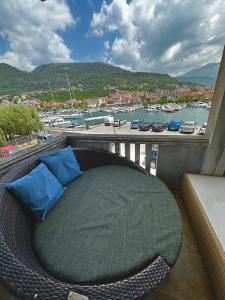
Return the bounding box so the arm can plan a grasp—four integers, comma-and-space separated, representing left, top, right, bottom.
182, 174, 225, 300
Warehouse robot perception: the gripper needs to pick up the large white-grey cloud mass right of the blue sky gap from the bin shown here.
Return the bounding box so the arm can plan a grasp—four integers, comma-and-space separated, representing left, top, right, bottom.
90, 0, 225, 75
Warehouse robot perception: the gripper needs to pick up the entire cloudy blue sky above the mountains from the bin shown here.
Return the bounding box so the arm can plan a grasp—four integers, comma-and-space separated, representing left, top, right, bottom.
0, 0, 225, 76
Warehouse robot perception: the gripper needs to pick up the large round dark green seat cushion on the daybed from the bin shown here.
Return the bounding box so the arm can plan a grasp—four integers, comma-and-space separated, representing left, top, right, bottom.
34, 166, 182, 284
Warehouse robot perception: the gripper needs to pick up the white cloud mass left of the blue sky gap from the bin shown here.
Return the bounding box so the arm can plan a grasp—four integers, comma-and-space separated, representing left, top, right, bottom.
0, 0, 76, 71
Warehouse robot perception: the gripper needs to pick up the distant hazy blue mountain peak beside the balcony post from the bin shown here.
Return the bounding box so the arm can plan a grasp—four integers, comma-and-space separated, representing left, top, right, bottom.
177, 63, 220, 86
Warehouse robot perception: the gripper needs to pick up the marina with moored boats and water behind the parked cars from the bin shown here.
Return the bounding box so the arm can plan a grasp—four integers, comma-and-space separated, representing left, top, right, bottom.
41, 106, 209, 133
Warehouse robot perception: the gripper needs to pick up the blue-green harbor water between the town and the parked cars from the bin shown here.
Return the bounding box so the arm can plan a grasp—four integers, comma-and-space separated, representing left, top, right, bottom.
78, 107, 209, 125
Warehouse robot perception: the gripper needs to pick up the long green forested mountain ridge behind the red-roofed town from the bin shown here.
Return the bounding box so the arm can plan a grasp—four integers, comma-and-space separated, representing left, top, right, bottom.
0, 62, 183, 95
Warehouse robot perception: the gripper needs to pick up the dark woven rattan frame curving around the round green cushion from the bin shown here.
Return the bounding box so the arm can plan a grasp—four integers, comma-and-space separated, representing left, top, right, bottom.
0, 149, 170, 300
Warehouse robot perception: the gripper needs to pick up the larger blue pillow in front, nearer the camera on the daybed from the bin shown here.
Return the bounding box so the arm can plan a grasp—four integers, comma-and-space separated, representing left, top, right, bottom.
7, 163, 64, 221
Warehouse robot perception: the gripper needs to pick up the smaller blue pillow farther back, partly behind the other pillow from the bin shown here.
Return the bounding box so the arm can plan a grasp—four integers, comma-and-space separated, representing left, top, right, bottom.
40, 146, 83, 186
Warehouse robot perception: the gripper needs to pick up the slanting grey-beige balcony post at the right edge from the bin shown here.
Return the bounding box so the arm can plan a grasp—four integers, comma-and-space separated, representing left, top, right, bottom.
201, 47, 225, 176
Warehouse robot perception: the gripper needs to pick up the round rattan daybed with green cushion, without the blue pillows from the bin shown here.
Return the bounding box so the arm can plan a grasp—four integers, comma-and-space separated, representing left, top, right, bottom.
0, 149, 182, 300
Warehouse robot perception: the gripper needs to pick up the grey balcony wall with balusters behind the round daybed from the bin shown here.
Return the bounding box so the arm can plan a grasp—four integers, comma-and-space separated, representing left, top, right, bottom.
0, 133, 208, 187
